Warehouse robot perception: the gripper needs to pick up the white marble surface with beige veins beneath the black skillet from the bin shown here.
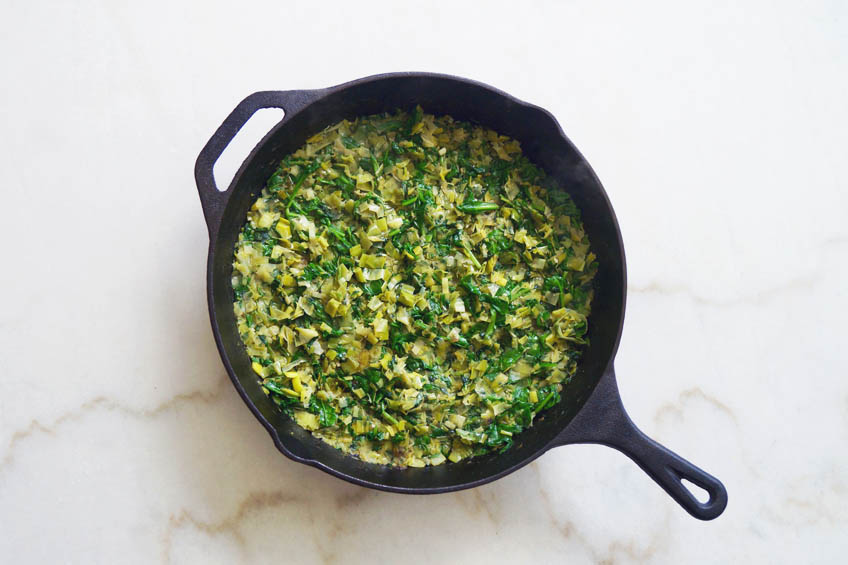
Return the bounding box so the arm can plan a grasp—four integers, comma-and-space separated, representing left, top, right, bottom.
0, 0, 848, 564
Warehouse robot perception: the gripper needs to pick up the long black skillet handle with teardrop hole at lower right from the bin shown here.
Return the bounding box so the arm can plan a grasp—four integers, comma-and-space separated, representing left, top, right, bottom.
552, 365, 727, 520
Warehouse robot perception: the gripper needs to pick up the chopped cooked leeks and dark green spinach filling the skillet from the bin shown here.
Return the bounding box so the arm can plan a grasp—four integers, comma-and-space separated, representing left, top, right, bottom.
232, 107, 597, 467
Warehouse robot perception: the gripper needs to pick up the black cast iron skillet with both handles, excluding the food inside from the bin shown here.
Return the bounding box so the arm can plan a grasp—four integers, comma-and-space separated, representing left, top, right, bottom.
194, 73, 727, 520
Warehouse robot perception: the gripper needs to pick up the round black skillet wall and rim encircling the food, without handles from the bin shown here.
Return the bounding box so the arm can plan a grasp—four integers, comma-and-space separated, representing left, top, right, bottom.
209, 75, 624, 492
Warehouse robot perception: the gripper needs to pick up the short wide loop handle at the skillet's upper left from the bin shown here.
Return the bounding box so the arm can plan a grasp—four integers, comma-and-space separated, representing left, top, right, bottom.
194, 90, 324, 239
